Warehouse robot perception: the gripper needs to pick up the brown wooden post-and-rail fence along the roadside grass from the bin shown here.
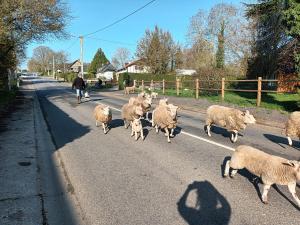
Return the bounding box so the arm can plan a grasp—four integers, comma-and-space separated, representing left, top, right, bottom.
134, 77, 300, 106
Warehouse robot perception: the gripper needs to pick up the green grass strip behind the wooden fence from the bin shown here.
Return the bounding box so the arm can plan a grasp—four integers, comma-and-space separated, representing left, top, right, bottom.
148, 89, 300, 112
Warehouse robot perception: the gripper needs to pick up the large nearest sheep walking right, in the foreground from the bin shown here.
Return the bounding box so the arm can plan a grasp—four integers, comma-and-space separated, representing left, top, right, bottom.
224, 145, 300, 207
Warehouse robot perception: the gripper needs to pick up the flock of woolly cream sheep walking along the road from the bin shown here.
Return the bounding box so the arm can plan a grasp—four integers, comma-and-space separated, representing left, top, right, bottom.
94, 90, 300, 208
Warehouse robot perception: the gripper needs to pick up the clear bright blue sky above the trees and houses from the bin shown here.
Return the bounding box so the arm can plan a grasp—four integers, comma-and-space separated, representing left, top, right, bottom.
21, 0, 251, 69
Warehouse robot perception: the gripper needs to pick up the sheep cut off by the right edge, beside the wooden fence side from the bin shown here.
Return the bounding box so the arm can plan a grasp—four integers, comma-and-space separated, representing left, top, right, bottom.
285, 111, 300, 146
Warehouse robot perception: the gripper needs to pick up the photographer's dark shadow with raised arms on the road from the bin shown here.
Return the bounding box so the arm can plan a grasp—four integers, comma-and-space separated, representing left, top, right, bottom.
177, 181, 231, 225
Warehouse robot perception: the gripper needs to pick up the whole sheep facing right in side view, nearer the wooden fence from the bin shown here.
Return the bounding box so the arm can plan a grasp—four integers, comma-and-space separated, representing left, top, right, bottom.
204, 105, 256, 143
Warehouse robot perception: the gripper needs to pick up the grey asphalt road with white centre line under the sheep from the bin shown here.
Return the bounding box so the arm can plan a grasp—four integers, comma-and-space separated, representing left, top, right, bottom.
33, 79, 300, 225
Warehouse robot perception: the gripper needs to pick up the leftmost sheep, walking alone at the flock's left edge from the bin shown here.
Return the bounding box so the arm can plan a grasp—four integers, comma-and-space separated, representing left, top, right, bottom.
94, 105, 112, 134
